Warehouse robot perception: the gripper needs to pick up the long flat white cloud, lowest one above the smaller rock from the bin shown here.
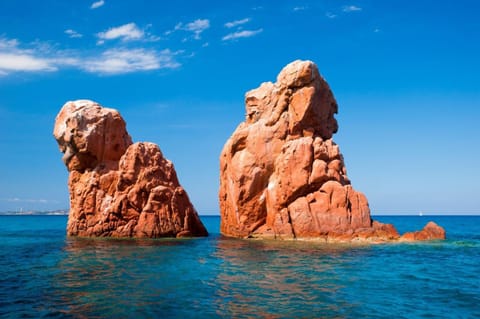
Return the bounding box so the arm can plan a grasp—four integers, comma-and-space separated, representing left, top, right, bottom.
79, 49, 180, 75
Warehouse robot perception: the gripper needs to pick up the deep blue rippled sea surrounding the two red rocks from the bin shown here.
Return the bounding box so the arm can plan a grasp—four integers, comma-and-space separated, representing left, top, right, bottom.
0, 216, 480, 318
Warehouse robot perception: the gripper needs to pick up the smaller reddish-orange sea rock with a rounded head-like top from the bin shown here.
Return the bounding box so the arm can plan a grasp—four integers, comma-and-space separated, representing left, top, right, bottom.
53, 100, 208, 238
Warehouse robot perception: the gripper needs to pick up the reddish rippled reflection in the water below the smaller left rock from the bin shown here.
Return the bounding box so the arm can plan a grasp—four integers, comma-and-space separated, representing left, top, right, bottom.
50, 238, 211, 318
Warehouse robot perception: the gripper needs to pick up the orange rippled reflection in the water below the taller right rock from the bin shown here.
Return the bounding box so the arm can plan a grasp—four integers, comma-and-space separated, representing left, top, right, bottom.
215, 239, 370, 318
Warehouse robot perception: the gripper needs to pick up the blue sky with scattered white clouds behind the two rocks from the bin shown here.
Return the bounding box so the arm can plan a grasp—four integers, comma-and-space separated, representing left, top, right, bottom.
0, 0, 480, 214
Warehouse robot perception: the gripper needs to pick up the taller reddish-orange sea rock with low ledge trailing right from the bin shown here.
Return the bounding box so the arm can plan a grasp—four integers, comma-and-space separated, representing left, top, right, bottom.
219, 61, 444, 242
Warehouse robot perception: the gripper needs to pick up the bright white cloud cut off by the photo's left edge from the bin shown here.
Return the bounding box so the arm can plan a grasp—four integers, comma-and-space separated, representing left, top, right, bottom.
0, 38, 57, 76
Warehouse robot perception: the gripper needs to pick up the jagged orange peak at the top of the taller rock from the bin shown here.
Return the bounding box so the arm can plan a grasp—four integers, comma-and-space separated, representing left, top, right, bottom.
245, 60, 338, 139
